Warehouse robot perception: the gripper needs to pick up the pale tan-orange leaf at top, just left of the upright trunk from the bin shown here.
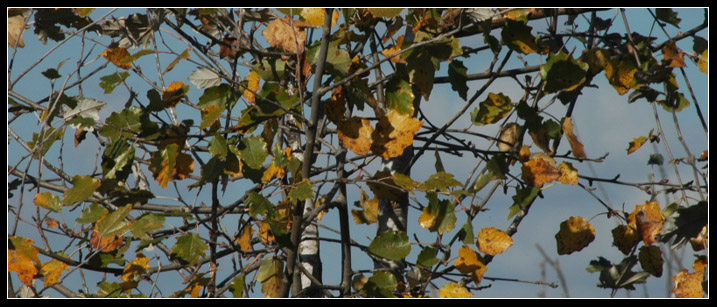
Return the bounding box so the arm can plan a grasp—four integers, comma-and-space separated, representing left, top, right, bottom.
262, 17, 306, 53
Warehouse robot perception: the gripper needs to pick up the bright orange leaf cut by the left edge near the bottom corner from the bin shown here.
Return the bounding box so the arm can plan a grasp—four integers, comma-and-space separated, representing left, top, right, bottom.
7, 237, 40, 286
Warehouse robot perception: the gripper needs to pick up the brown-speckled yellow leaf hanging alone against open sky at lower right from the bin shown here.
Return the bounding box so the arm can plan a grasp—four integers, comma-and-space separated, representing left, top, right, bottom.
555, 216, 595, 255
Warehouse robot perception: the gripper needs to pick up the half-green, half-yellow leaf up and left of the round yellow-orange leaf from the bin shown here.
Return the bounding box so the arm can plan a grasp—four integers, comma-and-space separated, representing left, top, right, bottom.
418, 192, 456, 234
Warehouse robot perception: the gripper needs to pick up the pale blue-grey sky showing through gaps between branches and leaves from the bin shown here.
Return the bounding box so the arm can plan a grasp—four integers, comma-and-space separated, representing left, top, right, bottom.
8, 9, 709, 297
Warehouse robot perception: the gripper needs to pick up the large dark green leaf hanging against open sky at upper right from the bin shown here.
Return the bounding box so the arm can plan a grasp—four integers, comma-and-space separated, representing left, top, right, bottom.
540, 52, 590, 93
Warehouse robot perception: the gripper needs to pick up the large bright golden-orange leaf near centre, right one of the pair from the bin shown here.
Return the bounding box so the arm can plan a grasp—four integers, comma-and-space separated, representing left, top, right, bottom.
371, 110, 423, 160
